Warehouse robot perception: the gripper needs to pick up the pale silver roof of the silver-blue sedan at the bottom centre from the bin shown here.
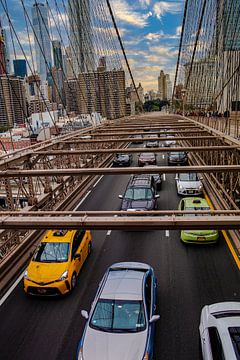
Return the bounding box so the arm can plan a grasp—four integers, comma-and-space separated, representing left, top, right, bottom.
100, 268, 146, 300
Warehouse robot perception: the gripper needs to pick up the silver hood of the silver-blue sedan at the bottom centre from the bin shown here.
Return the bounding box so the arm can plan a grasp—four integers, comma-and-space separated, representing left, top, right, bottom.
83, 327, 147, 360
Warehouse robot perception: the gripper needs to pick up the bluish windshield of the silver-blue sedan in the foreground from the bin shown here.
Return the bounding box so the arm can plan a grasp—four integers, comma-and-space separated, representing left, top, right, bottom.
90, 299, 146, 333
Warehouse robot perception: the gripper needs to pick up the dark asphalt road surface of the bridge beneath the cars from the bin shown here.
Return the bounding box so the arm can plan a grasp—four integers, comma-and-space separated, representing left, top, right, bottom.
0, 144, 240, 360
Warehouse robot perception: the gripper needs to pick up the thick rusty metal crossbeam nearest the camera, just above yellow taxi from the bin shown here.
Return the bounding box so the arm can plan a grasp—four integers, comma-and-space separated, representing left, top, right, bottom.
0, 215, 240, 231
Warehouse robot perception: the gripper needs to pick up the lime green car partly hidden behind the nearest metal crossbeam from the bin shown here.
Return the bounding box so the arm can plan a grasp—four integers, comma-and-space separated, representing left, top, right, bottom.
178, 197, 219, 244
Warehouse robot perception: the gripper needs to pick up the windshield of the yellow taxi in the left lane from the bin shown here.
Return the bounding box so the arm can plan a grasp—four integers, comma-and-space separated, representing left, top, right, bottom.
33, 242, 70, 263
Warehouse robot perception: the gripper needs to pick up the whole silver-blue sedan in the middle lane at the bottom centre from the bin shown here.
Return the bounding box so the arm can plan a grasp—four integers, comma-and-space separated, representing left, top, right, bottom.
77, 262, 160, 360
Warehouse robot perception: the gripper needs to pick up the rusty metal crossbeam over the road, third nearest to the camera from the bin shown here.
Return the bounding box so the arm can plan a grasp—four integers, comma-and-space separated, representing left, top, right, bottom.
35, 145, 240, 155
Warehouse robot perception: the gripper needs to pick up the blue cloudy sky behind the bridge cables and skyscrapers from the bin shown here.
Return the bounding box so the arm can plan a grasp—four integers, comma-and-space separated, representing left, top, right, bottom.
0, 0, 185, 92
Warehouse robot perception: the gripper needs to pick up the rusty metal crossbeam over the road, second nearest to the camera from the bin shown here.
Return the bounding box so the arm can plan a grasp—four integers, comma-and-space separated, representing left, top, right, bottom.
0, 165, 240, 178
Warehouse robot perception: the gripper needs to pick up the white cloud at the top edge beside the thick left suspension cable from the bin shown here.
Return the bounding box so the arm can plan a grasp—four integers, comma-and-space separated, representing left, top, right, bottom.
113, 0, 149, 28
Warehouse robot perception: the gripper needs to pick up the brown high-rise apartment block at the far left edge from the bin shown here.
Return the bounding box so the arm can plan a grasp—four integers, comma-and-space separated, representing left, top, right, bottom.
0, 75, 27, 128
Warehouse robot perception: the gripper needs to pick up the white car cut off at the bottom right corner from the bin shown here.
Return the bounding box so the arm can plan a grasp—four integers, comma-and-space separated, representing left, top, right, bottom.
199, 301, 240, 360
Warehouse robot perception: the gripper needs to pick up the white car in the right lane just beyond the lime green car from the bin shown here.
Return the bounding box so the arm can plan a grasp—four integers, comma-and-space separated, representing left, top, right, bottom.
175, 173, 203, 196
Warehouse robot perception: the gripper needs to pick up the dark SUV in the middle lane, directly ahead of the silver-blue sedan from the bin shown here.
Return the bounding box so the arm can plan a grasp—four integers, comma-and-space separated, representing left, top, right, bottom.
119, 175, 159, 211
